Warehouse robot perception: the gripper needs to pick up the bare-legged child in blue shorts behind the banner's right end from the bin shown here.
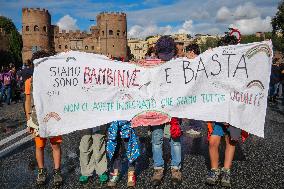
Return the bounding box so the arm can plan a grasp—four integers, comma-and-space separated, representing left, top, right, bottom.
206, 35, 247, 187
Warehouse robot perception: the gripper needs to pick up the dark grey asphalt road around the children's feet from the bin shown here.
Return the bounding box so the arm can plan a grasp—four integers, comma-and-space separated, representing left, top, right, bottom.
0, 99, 284, 189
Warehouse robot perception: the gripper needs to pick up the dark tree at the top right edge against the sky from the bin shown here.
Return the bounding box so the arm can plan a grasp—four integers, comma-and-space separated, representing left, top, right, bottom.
271, 0, 284, 54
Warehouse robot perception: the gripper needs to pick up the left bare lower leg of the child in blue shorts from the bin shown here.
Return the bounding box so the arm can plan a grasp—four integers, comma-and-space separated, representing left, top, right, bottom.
209, 135, 221, 169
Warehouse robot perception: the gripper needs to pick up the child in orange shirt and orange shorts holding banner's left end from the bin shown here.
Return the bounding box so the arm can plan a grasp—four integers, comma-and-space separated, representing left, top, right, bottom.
25, 51, 62, 186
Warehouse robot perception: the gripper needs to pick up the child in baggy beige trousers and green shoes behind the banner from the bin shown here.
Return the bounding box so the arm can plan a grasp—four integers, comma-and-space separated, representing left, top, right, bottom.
79, 125, 108, 184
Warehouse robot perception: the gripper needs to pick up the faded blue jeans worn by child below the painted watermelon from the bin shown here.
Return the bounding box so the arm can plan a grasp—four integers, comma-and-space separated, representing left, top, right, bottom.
152, 125, 181, 169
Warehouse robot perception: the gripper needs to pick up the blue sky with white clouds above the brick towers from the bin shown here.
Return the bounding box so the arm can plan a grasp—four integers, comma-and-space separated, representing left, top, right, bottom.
0, 0, 281, 38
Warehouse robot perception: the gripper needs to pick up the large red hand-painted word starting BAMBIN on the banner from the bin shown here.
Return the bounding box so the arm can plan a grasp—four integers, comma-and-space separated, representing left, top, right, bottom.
84, 67, 140, 88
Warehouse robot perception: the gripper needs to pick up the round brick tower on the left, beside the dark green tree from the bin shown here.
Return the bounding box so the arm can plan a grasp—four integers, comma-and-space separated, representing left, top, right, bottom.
22, 8, 51, 63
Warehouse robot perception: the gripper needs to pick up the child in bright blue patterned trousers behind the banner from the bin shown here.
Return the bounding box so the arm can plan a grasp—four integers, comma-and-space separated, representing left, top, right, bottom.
107, 121, 140, 187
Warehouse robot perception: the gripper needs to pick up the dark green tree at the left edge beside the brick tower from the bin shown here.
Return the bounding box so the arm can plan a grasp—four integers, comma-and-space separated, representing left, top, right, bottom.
0, 16, 23, 67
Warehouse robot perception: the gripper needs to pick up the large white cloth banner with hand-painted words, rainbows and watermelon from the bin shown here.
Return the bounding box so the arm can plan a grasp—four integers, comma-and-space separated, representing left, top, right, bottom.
33, 41, 272, 137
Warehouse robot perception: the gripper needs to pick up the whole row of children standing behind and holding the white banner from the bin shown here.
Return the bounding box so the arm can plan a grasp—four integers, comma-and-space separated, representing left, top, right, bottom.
22, 36, 272, 187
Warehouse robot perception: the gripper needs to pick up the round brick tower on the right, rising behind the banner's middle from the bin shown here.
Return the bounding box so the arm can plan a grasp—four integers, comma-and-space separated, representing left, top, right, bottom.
97, 12, 127, 58
